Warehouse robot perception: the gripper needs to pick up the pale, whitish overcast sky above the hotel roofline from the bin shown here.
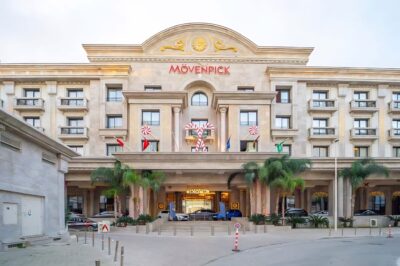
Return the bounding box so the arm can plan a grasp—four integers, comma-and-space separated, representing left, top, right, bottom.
0, 0, 400, 68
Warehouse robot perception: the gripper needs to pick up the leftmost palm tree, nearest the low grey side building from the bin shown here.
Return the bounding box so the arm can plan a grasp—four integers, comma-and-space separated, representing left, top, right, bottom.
90, 160, 128, 218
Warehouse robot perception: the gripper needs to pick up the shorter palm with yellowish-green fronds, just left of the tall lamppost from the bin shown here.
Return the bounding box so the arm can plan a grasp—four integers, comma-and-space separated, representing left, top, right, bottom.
270, 172, 304, 225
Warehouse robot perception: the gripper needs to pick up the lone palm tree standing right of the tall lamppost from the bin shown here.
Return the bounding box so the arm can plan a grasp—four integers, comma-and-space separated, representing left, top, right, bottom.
340, 159, 389, 216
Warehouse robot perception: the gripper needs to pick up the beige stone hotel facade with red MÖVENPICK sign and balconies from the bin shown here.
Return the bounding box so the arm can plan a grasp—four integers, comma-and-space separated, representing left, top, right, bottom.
0, 23, 400, 216
